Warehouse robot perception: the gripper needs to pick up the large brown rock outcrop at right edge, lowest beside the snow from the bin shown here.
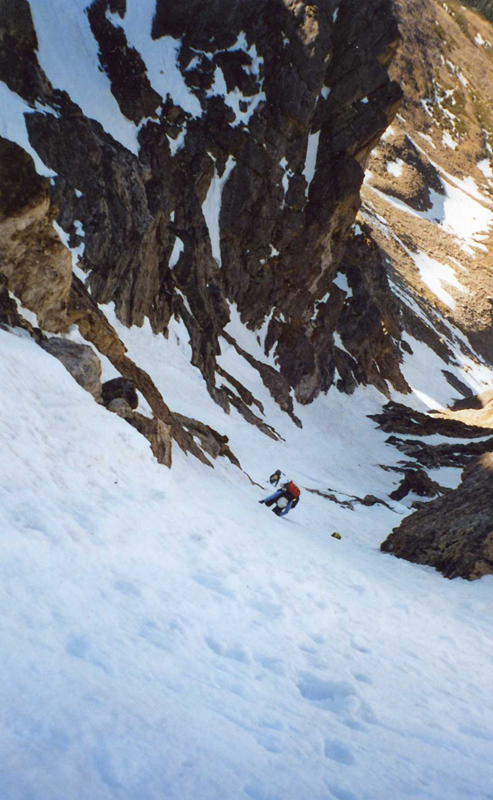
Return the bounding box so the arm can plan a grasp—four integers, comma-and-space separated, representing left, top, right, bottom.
381, 453, 493, 580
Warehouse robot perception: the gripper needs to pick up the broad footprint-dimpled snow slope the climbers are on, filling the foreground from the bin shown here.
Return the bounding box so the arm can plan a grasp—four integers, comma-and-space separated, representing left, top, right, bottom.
0, 296, 493, 800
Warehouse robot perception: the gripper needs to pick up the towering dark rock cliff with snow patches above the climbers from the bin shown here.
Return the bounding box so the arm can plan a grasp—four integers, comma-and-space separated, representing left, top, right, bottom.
0, 0, 406, 462
